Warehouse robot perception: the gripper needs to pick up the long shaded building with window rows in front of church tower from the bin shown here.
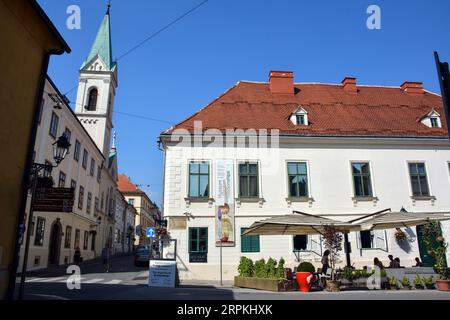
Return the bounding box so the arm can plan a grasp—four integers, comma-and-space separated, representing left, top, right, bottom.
19, 78, 105, 270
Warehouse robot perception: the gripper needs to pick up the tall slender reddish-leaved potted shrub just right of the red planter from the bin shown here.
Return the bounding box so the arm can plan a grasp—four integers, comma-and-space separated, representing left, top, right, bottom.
323, 225, 343, 292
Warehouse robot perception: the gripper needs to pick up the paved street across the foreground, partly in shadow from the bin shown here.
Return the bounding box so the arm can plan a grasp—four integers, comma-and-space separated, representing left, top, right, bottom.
14, 256, 450, 300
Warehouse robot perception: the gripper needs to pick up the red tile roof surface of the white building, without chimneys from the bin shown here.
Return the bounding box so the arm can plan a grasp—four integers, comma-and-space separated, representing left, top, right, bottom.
163, 81, 448, 137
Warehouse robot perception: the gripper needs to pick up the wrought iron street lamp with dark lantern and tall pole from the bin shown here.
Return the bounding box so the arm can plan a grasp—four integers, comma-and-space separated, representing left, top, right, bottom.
19, 134, 70, 300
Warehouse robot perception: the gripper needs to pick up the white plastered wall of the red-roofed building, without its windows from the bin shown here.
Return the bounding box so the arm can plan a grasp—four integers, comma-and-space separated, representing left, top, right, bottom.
164, 140, 450, 279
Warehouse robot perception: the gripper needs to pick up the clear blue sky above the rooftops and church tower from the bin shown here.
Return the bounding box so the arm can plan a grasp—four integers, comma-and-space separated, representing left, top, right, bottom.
39, 0, 450, 205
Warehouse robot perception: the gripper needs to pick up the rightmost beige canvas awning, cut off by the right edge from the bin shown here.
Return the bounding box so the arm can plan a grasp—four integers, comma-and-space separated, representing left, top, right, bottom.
349, 211, 450, 230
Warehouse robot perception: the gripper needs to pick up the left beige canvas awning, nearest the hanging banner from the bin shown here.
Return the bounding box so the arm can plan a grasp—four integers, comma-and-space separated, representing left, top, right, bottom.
243, 211, 360, 235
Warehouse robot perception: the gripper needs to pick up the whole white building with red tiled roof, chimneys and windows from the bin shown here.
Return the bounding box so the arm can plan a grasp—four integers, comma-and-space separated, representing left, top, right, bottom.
160, 72, 450, 280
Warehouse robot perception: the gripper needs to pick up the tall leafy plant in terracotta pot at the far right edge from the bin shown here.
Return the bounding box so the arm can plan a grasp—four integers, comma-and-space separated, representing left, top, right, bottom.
424, 221, 450, 291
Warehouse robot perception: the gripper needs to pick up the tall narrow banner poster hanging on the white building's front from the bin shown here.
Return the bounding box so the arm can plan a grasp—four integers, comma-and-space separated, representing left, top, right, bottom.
215, 160, 235, 247
